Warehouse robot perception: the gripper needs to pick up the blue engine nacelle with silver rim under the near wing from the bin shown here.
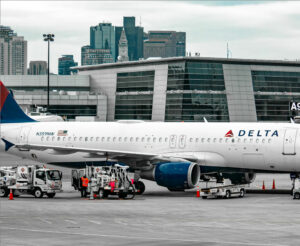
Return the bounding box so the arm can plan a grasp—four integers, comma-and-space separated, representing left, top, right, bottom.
140, 162, 200, 190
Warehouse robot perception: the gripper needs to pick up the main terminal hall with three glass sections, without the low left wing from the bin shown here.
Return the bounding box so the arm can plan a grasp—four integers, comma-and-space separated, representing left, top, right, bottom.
77, 57, 300, 122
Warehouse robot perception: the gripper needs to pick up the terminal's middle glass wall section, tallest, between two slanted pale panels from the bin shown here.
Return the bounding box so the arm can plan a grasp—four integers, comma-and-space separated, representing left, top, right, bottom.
165, 61, 229, 121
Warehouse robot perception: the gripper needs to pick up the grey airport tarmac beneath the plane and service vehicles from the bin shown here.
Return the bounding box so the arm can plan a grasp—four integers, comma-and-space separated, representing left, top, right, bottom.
0, 153, 300, 246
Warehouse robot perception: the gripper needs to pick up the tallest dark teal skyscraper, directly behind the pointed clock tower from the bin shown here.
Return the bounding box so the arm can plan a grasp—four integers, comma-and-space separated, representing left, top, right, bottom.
115, 16, 144, 61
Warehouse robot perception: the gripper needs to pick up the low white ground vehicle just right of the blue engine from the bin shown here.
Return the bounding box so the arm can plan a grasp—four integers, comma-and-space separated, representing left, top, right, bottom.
200, 179, 246, 199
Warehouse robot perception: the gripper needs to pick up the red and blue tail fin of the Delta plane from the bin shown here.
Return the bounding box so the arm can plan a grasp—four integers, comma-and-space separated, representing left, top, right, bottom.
0, 81, 35, 123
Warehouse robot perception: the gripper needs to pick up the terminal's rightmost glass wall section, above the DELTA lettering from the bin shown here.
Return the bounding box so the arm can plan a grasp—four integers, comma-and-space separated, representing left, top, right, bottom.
251, 71, 300, 121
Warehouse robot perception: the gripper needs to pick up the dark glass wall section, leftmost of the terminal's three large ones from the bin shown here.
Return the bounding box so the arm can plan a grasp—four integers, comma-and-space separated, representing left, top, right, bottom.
115, 71, 155, 120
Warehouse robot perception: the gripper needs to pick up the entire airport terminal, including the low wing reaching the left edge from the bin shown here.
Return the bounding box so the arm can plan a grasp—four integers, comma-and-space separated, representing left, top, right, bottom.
0, 57, 300, 122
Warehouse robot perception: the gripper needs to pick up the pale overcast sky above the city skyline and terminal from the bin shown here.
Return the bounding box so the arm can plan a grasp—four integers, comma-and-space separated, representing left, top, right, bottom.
0, 0, 300, 73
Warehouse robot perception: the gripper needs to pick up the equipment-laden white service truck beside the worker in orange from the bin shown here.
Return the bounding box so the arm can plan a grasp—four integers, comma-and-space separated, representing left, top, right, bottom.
71, 164, 135, 199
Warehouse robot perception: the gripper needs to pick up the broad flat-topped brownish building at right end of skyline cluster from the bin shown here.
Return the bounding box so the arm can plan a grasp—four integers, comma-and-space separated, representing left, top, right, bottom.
144, 31, 186, 59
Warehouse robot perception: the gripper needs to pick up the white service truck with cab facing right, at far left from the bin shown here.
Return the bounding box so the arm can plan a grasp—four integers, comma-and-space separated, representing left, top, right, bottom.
0, 165, 62, 198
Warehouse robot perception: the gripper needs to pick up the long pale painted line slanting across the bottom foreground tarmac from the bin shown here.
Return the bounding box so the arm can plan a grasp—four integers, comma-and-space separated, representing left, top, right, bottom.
0, 227, 288, 246
